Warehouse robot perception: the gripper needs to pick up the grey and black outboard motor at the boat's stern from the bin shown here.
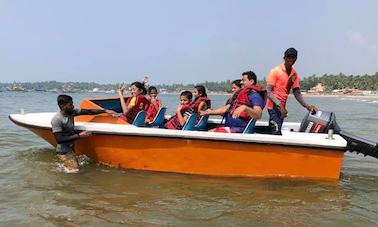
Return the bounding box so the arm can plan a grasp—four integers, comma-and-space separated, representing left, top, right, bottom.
299, 110, 378, 158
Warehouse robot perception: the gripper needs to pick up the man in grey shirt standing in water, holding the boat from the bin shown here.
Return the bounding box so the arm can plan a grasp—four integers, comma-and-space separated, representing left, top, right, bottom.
51, 95, 116, 171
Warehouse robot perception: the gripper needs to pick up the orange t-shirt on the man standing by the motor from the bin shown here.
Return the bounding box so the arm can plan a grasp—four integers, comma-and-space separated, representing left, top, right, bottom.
266, 64, 299, 109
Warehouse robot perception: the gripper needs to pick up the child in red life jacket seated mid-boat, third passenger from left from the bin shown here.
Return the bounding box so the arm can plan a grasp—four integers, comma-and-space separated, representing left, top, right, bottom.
164, 91, 194, 130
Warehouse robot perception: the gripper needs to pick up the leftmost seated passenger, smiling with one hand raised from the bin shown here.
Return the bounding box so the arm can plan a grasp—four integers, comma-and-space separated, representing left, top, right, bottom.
118, 82, 150, 124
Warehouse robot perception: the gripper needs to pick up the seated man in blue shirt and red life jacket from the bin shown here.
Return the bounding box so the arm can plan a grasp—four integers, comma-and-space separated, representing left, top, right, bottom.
200, 71, 266, 133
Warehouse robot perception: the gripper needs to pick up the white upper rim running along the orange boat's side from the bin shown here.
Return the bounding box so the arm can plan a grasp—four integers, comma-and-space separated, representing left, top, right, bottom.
9, 112, 347, 150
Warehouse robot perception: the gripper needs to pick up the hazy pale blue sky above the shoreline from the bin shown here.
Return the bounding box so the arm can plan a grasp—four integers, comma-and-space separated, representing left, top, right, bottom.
0, 0, 378, 84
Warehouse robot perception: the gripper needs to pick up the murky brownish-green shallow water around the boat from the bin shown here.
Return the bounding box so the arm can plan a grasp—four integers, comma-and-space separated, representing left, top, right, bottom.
0, 92, 378, 226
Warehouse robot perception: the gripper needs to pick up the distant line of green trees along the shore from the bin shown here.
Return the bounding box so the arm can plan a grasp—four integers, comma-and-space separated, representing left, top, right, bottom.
0, 72, 378, 92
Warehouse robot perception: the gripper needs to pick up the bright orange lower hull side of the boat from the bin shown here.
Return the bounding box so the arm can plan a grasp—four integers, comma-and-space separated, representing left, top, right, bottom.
28, 127, 344, 180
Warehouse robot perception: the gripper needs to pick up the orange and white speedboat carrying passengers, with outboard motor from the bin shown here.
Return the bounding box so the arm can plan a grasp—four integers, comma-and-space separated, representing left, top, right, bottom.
9, 97, 378, 180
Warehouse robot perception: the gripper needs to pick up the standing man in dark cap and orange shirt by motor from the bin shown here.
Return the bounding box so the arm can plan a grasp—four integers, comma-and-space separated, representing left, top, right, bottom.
266, 48, 317, 135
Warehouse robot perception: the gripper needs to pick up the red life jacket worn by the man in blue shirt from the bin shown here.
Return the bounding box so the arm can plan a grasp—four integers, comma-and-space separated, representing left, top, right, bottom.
229, 85, 267, 120
